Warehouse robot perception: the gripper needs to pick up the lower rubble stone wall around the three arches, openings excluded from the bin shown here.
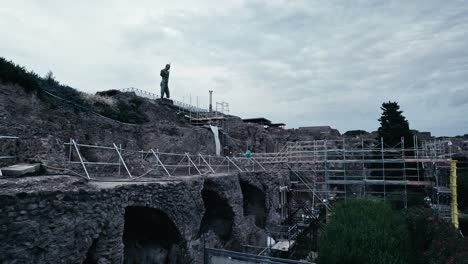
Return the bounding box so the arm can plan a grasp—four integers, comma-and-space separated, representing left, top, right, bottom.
0, 173, 284, 263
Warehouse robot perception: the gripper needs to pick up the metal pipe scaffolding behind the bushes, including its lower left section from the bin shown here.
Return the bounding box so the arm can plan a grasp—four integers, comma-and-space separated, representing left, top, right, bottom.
245, 137, 458, 258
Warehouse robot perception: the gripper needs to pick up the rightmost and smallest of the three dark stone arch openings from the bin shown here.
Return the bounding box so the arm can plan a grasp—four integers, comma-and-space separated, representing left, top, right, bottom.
240, 181, 268, 229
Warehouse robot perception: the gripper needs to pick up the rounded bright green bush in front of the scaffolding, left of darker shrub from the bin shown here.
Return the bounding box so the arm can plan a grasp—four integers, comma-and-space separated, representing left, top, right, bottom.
318, 199, 410, 264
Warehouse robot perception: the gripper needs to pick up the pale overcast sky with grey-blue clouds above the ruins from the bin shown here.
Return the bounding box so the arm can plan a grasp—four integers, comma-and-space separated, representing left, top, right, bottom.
0, 0, 468, 135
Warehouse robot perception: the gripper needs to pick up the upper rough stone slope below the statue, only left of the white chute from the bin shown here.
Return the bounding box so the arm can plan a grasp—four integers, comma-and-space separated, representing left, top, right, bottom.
0, 84, 215, 164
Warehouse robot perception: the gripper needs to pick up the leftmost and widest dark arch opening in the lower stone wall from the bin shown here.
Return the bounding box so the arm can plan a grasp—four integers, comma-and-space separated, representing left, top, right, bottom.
123, 206, 184, 264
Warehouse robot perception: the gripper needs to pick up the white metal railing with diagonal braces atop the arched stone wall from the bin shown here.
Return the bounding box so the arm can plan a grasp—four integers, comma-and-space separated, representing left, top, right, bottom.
65, 139, 266, 180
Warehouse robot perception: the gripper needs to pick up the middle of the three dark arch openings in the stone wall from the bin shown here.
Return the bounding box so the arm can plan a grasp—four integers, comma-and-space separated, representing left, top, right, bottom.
200, 188, 234, 242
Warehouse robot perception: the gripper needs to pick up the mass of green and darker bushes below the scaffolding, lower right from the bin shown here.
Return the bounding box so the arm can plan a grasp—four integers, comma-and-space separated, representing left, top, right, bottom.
318, 199, 468, 264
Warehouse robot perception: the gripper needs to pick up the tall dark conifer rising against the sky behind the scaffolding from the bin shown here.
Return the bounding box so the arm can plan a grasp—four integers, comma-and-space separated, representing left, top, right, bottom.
377, 101, 413, 148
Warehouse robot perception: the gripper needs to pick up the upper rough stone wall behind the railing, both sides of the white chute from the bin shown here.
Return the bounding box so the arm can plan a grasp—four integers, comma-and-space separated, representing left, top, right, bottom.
0, 84, 344, 165
